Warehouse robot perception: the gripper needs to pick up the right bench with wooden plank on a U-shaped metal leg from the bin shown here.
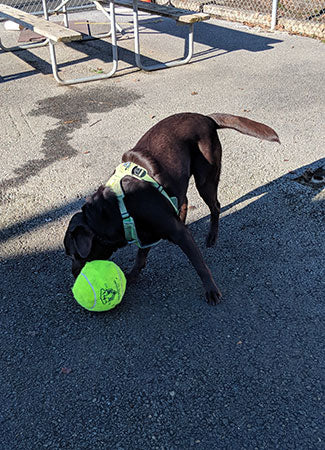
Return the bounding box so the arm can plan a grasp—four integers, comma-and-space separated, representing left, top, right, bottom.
98, 0, 210, 71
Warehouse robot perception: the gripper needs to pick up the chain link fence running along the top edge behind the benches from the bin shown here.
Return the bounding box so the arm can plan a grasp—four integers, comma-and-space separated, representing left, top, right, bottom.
1, 0, 325, 39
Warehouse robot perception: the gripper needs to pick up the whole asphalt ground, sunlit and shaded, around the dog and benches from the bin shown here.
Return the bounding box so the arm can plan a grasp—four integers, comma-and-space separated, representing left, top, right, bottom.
0, 10, 325, 450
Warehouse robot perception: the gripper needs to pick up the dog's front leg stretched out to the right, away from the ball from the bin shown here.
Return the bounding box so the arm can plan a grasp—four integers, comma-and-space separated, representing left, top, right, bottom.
170, 222, 222, 305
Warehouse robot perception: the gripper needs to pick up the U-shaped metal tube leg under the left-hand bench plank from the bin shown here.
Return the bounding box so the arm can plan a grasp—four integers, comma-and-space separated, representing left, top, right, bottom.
49, 2, 118, 85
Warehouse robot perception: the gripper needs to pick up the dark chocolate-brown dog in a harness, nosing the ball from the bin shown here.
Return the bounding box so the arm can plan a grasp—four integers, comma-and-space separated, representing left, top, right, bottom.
64, 113, 280, 304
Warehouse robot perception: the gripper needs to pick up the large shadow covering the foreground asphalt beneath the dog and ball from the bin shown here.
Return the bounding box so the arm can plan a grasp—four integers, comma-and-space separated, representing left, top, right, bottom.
0, 160, 324, 449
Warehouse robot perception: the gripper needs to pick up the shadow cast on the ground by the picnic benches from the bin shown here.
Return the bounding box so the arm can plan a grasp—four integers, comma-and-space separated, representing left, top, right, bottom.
0, 18, 282, 83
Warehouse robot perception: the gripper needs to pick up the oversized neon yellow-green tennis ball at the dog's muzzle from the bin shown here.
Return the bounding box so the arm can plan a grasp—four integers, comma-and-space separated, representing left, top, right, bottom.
72, 261, 126, 311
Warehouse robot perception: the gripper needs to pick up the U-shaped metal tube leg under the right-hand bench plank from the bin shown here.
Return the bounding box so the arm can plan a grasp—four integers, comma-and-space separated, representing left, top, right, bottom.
133, 0, 194, 71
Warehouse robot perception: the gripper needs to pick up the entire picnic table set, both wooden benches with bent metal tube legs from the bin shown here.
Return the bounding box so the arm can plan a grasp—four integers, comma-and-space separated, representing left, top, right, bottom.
0, 0, 210, 85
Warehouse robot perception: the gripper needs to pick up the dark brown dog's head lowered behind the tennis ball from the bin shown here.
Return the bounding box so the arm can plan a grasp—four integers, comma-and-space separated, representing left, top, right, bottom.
64, 187, 127, 278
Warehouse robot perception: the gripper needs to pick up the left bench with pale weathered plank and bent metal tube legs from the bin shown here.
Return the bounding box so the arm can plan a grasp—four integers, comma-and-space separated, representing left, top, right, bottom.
0, 0, 118, 85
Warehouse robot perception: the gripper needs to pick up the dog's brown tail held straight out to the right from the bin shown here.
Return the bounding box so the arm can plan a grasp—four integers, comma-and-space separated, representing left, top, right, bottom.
208, 113, 280, 144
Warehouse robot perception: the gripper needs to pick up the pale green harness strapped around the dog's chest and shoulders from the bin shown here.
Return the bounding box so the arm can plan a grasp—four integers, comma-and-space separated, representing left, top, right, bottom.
105, 162, 178, 248
